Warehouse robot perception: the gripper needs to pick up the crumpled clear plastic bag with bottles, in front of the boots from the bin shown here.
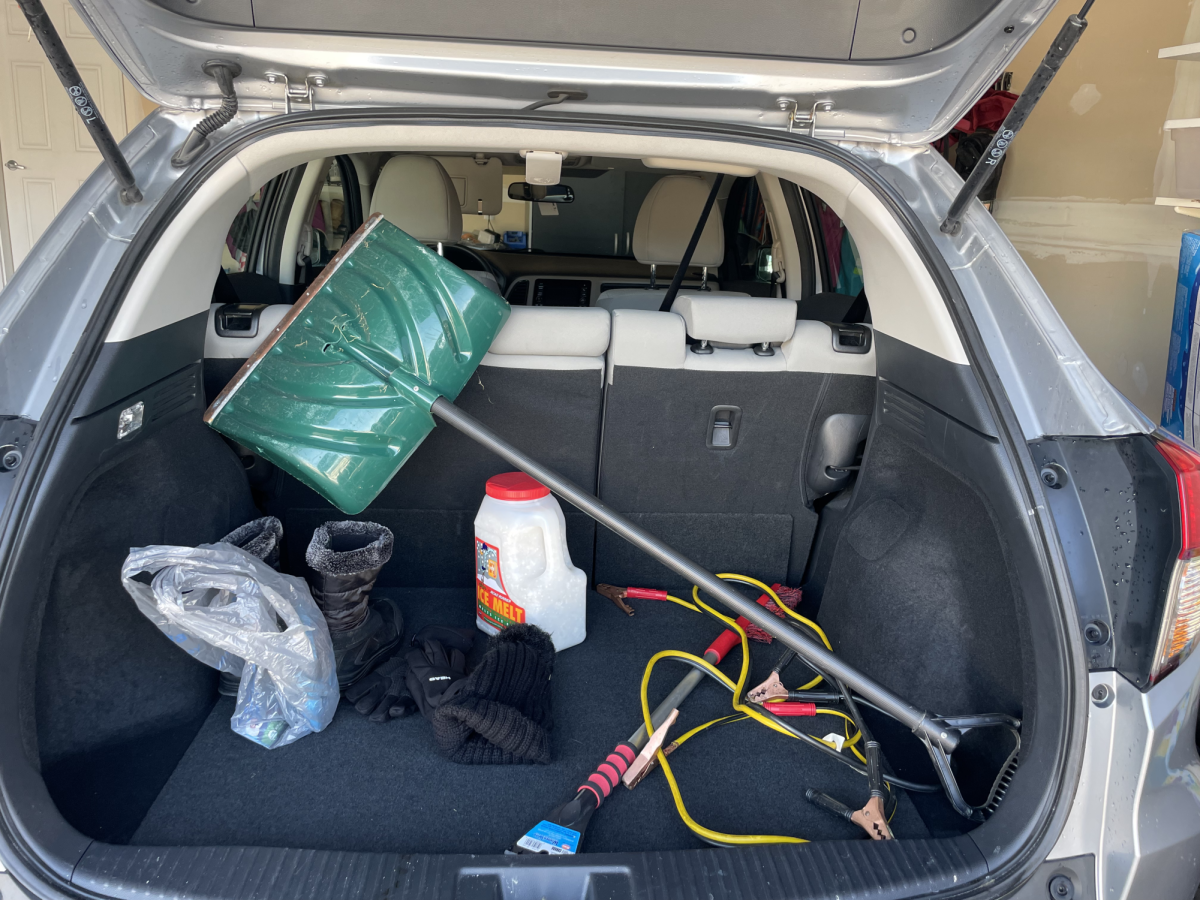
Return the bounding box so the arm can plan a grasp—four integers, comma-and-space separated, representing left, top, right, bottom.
121, 544, 338, 749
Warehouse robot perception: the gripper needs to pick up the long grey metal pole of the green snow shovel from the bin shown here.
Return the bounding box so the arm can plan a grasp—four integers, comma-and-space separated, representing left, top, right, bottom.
430, 397, 961, 754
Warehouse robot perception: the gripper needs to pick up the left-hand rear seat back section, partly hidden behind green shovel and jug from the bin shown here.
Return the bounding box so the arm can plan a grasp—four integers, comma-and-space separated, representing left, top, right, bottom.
276, 306, 611, 587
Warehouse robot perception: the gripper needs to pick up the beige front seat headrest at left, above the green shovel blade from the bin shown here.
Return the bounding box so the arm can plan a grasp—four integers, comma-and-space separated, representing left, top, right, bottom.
371, 156, 462, 244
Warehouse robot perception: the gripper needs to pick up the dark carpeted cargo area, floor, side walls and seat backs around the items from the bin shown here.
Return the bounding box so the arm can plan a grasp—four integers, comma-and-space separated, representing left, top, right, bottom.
32, 340, 1025, 853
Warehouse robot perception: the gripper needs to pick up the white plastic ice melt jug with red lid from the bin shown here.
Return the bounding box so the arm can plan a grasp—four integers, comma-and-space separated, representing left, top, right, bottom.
475, 472, 587, 650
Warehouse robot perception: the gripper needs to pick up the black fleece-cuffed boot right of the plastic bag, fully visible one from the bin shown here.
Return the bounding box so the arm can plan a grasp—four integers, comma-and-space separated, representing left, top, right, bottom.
305, 521, 404, 690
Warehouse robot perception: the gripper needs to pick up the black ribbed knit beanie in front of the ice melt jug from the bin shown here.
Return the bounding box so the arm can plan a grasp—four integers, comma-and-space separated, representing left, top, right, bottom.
433, 625, 554, 766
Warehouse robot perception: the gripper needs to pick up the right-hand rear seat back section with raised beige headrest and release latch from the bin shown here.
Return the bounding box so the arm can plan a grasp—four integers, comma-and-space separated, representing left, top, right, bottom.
595, 295, 875, 588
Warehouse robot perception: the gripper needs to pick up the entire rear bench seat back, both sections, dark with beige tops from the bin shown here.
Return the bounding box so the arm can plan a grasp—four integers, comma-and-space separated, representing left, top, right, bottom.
255, 157, 875, 588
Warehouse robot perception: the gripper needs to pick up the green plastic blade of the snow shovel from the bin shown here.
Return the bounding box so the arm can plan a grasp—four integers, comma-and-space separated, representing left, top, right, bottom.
204, 214, 509, 515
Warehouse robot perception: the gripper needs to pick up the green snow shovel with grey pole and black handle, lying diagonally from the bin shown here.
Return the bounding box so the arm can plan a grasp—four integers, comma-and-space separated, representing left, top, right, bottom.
204, 214, 1014, 818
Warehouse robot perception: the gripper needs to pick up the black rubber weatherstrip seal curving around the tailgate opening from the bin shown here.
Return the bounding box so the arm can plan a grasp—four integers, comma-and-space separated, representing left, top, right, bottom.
0, 109, 1087, 898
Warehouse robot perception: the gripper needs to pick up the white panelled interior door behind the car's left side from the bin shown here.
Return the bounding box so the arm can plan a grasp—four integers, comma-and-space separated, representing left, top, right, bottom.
0, 0, 127, 268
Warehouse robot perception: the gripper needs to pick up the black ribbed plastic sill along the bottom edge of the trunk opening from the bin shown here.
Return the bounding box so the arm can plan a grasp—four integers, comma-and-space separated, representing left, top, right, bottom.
72, 844, 988, 900
